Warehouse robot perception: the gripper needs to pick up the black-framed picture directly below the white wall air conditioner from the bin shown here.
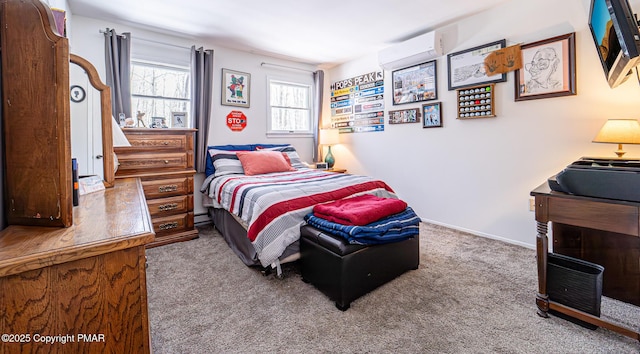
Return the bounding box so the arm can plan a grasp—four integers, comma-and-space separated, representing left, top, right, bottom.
391, 60, 438, 105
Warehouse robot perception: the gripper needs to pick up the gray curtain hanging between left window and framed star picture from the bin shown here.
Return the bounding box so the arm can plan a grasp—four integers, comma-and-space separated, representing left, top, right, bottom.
191, 46, 213, 172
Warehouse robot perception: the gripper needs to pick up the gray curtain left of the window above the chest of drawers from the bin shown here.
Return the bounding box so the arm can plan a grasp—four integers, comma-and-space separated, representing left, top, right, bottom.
104, 28, 132, 121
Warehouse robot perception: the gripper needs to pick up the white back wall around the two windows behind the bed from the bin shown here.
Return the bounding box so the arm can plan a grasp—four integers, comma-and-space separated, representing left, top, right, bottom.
70, 16, 313, 215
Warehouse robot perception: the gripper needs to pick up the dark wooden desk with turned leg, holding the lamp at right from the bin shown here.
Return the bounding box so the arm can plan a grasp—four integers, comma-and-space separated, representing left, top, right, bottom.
531, 182, 640, 340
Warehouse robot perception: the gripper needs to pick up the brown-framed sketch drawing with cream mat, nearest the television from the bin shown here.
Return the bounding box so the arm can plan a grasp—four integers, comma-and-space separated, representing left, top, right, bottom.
515, 32, 576, 101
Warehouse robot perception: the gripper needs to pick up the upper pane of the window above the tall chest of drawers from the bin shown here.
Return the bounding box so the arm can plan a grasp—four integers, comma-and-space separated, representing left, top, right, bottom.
131, 64, 190, 99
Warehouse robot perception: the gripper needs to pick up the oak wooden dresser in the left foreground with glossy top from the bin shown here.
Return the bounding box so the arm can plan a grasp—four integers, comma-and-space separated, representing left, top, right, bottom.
0, 178, 154, 354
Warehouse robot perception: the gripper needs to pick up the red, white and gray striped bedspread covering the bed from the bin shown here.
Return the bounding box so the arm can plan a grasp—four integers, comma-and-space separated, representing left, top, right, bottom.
201, 169, 397, 267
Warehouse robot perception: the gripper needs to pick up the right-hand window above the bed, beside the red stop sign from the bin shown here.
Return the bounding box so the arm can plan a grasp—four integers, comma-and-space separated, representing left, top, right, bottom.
267, 79, 313, 136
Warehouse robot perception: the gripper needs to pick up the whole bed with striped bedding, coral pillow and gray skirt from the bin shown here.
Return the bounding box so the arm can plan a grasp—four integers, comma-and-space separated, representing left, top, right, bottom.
200, 144, 397, 272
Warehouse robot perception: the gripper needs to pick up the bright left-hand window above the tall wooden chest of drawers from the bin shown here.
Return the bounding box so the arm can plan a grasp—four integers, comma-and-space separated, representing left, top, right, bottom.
131, 61, 192, 128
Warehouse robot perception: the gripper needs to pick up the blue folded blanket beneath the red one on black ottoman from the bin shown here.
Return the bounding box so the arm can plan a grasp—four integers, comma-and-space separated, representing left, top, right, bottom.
304, 207, 420, 245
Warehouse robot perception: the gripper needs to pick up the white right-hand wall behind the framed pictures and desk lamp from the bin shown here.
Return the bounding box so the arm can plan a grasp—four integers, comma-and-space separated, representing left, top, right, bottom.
324, 0, 640, 247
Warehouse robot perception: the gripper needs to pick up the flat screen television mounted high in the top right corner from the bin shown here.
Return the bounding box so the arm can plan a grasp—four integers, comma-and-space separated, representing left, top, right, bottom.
589, 0, 640, 88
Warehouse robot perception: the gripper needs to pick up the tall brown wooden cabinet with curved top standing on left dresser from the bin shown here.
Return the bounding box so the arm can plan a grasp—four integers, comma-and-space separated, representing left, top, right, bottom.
0, 0, 73, 227
